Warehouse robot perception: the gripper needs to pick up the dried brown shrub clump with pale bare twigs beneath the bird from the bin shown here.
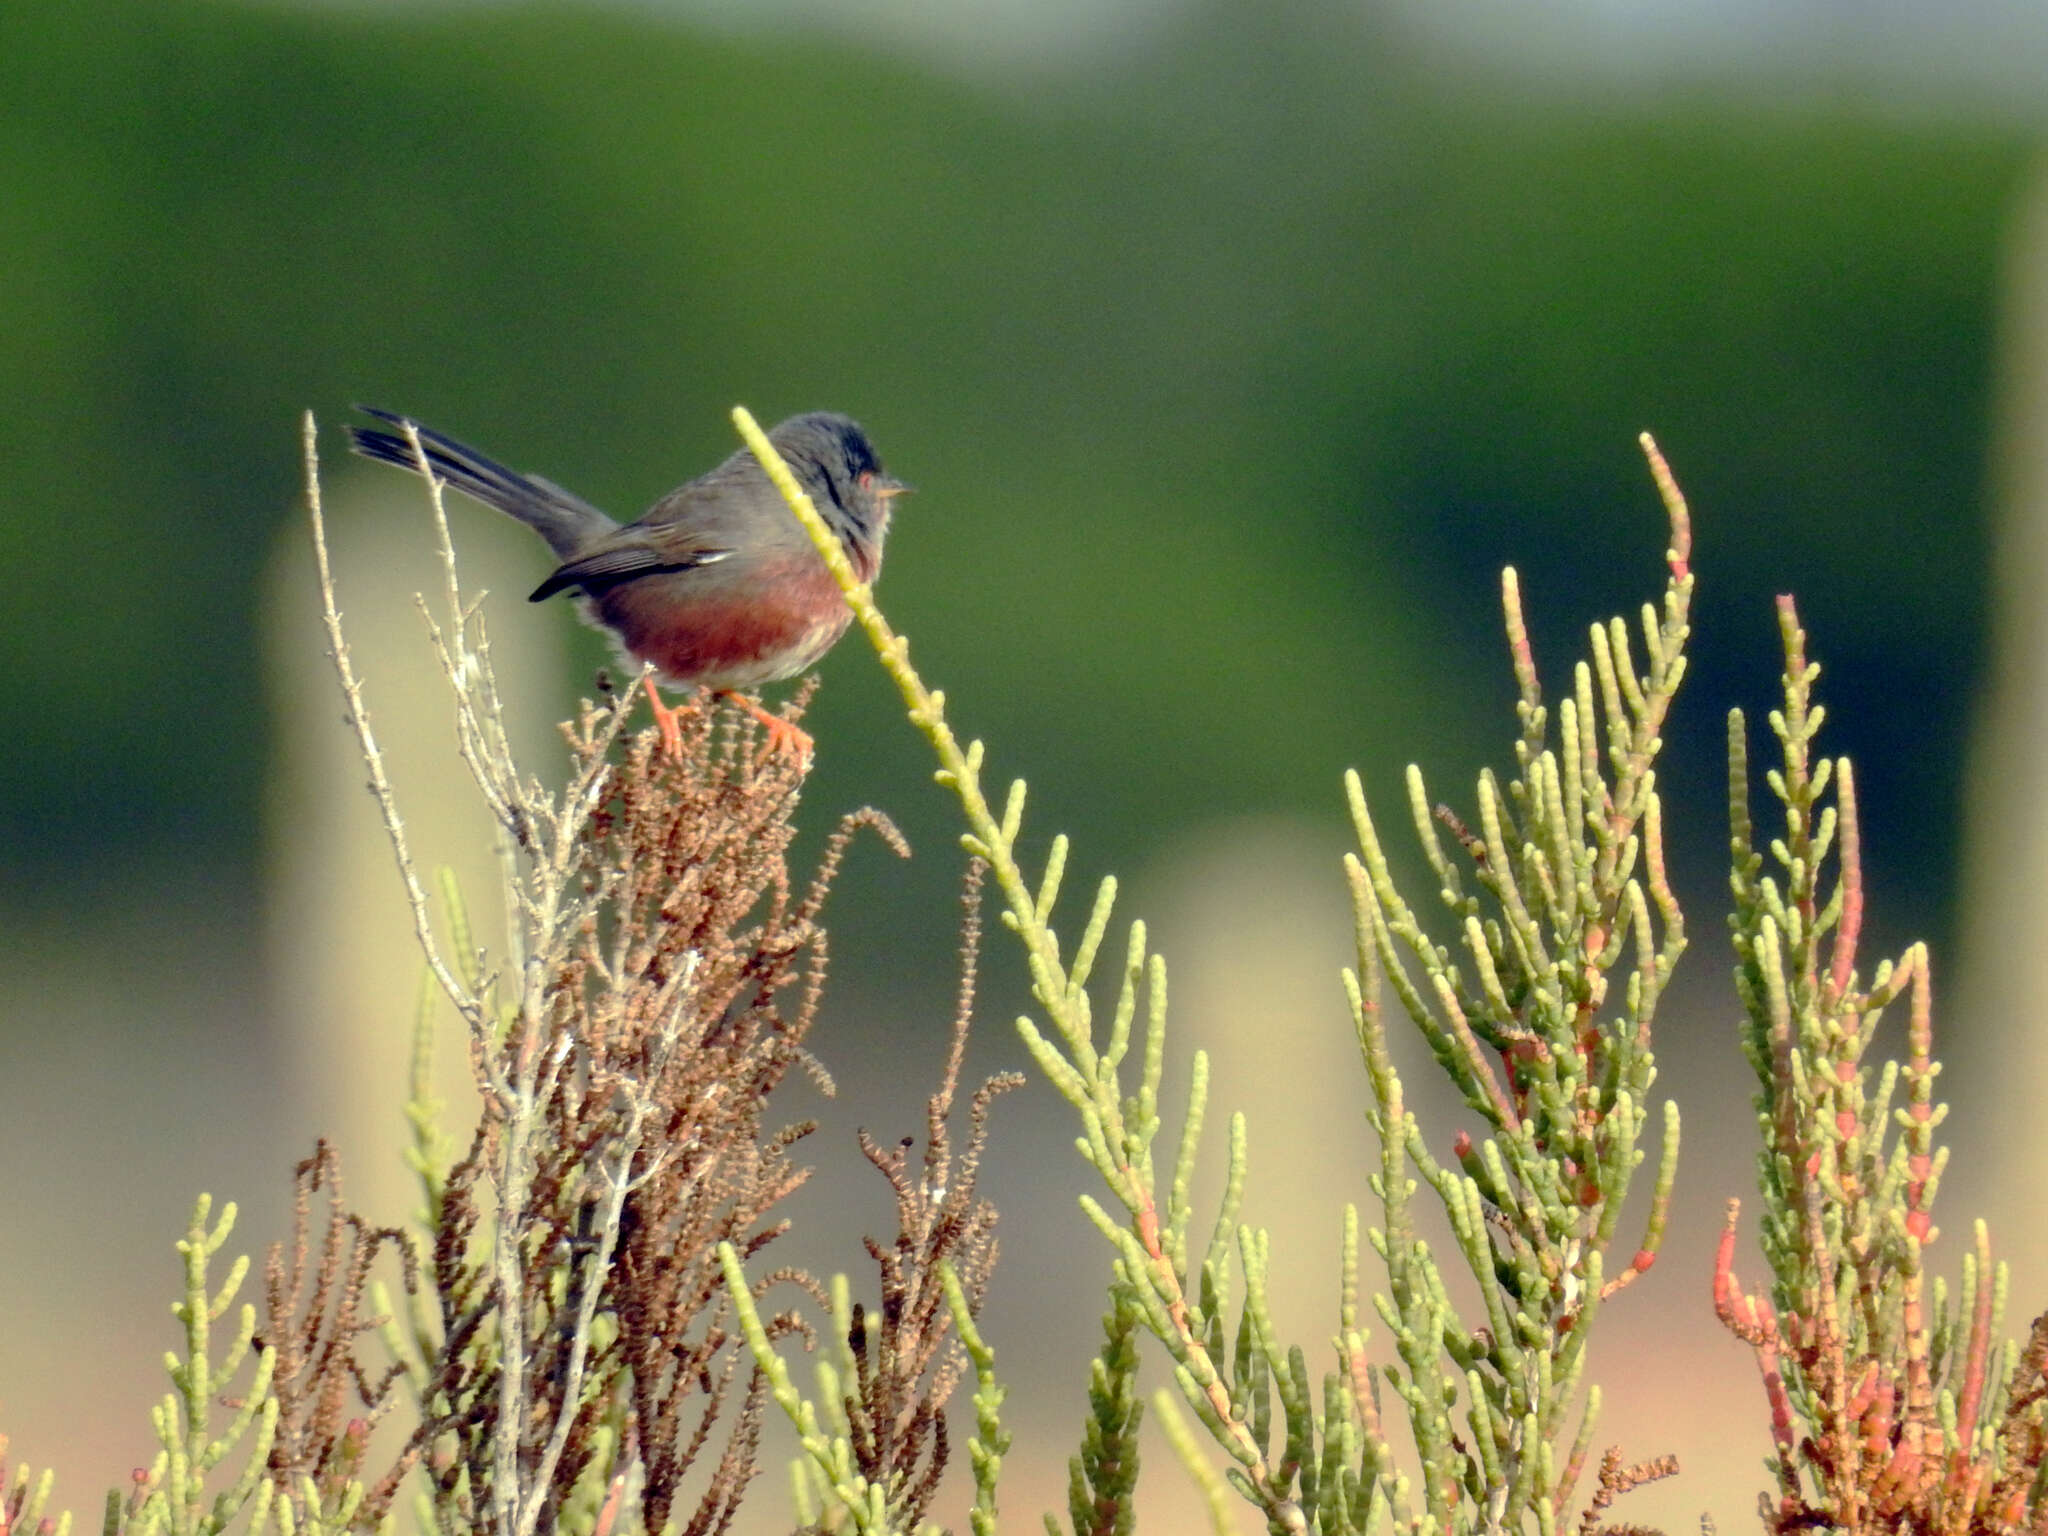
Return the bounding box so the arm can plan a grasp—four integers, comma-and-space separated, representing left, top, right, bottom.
307, 422, 901, 1536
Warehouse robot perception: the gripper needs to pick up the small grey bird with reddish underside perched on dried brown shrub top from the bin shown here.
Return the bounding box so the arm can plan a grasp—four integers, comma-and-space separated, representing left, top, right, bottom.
348, 406, 909, 758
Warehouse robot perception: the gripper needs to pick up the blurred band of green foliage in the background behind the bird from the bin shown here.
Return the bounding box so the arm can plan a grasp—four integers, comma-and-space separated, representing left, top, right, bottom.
0, 0, 2030, 950
